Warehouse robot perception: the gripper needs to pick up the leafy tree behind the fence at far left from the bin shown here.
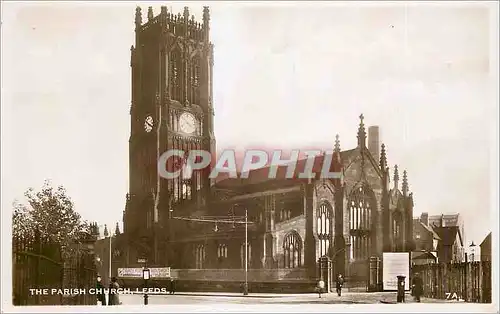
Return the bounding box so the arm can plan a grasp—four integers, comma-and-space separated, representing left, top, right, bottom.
12, 181, 92, 252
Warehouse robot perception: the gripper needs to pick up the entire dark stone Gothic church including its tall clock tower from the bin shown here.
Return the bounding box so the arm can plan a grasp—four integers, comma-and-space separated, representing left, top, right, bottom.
111, 7, 414, 292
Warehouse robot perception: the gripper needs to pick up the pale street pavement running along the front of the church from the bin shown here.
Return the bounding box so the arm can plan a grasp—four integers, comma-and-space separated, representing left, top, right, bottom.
114, 292, 457, 305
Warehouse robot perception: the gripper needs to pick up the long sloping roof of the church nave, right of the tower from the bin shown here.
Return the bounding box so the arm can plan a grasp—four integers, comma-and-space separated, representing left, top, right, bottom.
215, 149, 356, 189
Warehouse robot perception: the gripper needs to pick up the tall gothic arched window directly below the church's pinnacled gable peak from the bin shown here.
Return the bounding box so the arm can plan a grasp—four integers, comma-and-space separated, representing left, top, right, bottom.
349, 186, 373, 260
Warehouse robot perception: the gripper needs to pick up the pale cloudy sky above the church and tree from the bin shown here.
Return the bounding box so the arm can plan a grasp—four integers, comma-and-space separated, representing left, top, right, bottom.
1, 2, 498, 242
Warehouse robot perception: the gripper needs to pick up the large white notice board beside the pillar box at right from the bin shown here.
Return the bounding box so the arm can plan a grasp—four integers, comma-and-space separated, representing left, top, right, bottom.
382, 252, 411, 291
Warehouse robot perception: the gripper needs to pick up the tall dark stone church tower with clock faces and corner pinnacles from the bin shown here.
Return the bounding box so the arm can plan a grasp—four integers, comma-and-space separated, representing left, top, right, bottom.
123, 6, 215, 264
